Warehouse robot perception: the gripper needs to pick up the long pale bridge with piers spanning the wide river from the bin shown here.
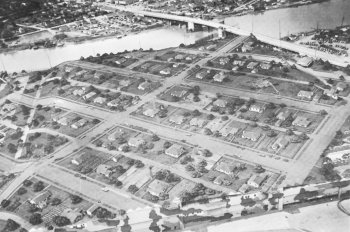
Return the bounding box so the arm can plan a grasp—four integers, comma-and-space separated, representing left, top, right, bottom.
110, 6, 350, 67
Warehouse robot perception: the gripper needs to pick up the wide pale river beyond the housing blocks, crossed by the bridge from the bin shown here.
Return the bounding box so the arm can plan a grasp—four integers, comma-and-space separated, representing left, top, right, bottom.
0, 0, 350, 72
